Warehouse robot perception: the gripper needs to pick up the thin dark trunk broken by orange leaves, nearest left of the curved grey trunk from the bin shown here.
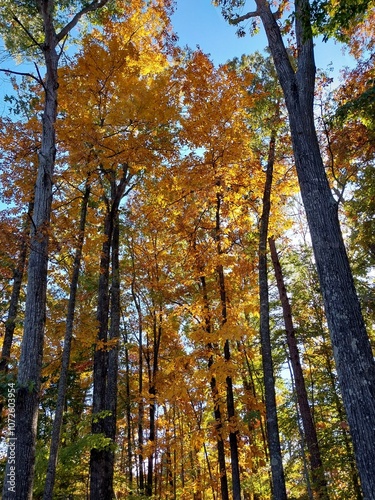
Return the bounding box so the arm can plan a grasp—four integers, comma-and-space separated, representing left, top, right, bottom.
215, 193, 241, 500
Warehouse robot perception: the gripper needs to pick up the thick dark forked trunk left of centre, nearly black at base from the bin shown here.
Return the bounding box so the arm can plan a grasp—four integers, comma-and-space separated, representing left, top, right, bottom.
90, 165, 132, 500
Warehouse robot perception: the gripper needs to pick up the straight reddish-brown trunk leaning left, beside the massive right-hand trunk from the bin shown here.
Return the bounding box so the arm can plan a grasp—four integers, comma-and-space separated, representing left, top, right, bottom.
268, 238, 329, 500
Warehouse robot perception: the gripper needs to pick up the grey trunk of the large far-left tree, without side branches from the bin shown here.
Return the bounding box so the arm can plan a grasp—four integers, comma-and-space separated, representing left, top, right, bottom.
3, 8, 59, 500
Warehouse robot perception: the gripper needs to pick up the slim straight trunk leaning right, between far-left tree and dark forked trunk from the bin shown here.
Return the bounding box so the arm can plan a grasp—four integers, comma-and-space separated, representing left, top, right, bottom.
43, 184, 90, 500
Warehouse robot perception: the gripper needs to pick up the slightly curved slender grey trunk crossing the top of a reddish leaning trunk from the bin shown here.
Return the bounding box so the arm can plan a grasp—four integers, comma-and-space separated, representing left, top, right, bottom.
259, 134, 287, 500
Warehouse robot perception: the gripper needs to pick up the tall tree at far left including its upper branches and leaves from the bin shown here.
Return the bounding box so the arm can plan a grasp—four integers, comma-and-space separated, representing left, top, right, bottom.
3, 0, 108, 499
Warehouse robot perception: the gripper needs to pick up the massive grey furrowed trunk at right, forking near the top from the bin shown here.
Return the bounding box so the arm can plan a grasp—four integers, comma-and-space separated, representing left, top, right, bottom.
256, 0, 375, 499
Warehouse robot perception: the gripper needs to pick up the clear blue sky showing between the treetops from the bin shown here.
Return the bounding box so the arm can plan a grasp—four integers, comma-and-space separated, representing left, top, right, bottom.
172, 0, 353, 74
